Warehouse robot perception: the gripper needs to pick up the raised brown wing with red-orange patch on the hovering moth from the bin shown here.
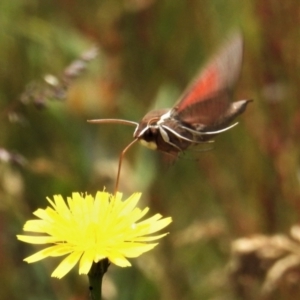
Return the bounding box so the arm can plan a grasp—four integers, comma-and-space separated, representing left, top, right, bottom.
173, 33, 243, 125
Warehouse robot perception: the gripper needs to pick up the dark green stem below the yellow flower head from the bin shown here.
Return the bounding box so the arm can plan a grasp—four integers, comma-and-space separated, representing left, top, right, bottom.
88, 258, 109, 300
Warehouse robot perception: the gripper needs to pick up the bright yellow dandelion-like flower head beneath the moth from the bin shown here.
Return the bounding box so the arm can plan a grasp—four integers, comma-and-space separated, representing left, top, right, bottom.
17, 192, 172, 278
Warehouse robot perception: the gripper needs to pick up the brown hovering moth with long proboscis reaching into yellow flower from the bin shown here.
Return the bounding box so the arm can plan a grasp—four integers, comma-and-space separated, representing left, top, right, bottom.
89, 33, 252, 191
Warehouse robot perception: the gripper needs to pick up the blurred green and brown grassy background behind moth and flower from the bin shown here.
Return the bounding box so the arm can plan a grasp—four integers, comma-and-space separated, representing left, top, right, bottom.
0, 0, 300, 300
